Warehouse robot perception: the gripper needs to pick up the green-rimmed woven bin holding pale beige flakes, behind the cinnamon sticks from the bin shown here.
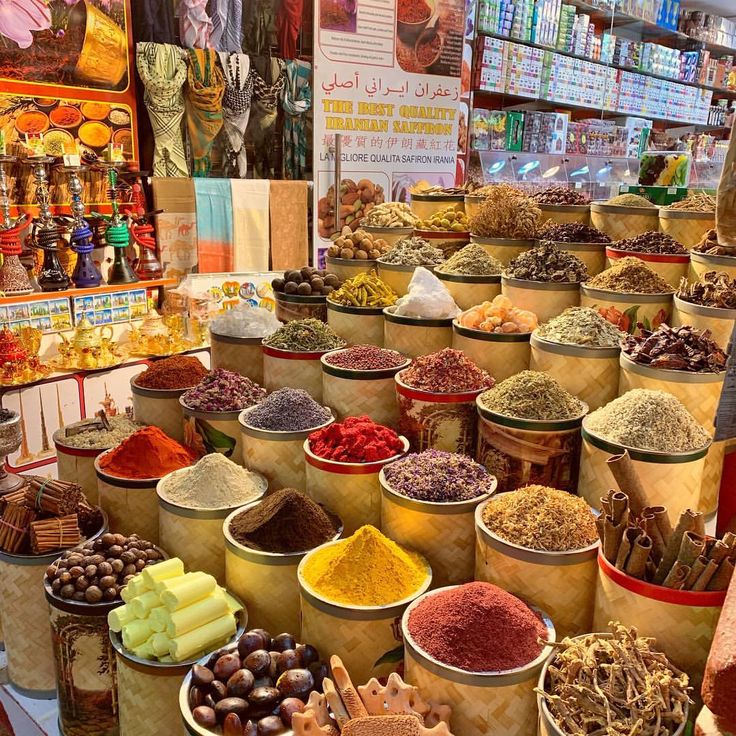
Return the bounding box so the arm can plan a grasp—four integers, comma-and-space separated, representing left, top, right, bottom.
578, 420, 710, 526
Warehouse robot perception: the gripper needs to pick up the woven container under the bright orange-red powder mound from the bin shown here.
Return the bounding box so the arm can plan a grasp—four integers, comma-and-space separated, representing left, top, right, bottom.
95, 458, 161, 544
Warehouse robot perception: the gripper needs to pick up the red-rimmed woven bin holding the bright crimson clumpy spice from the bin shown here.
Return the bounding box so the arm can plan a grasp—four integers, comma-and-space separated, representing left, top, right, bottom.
304, 437, 409, 536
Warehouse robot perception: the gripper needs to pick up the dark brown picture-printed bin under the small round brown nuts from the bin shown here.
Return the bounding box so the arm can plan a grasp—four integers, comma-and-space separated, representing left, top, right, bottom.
44, 581, 122, 736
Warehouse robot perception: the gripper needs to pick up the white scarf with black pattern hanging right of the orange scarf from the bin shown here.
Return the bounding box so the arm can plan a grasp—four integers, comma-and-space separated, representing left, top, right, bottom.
220, 51, 253, 179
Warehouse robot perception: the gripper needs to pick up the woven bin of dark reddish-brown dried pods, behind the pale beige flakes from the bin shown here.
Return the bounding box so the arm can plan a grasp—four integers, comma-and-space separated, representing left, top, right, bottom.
619, 354, 726, 514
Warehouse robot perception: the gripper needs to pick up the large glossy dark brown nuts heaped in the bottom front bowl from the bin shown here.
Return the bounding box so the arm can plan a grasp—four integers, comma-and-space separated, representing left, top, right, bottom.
188, 629, 328, 736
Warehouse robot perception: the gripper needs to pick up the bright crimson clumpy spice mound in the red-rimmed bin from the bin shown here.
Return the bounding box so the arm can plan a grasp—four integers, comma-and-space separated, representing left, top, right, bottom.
309, 416, 404, 463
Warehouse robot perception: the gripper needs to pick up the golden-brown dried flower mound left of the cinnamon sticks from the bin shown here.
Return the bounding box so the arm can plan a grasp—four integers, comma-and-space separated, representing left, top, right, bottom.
483, 485, 598, 552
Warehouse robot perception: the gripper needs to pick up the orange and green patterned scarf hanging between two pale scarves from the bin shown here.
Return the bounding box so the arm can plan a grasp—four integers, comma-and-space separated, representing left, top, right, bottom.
186, 49, 225, 176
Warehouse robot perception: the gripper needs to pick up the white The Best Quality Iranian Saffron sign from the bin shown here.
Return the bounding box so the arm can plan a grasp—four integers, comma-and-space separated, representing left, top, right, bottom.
314, 0, 465, 260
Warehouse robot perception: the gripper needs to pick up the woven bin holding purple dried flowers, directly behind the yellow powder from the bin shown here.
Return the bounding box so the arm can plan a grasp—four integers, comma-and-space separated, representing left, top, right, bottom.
378, 470, 496, 588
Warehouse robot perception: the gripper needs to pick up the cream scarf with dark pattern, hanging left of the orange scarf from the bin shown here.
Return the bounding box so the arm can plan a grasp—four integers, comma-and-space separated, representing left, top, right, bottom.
136, 41, 189, 176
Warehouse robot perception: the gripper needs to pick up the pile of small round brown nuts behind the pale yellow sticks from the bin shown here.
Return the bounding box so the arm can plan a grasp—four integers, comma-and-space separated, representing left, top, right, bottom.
46, 532, 163, 603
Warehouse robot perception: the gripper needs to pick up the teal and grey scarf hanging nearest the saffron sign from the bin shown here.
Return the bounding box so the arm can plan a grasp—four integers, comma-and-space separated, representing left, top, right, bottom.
281, 60, 312, 179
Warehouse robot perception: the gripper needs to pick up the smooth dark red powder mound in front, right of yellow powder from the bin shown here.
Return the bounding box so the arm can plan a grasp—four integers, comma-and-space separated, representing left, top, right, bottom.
409, 582, 547, 672
